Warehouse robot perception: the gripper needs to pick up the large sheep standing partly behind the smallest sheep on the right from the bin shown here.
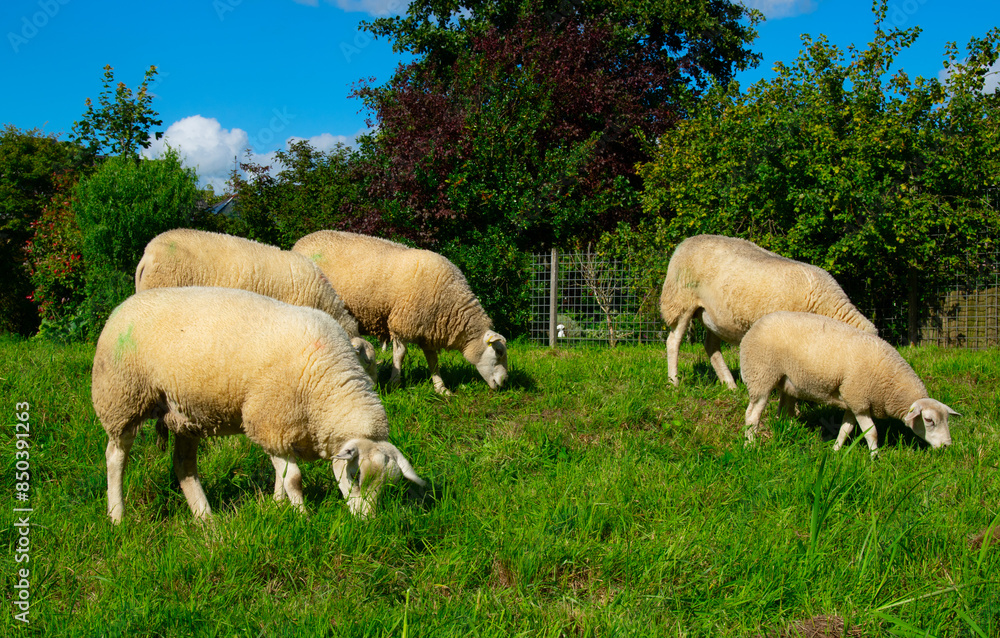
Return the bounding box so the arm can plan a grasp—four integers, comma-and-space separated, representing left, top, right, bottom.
660, 235, 878, 390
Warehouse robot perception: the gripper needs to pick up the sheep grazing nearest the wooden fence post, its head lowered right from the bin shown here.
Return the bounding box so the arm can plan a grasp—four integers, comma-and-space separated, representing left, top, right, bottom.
292, 230, 507, 395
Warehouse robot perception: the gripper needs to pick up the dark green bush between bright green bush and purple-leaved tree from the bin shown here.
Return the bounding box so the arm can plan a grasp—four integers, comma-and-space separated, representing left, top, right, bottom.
227, 140, 370, 249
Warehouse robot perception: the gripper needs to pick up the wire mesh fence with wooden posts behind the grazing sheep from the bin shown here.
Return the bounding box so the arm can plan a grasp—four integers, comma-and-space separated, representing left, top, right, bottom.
530, 248, 1000, 349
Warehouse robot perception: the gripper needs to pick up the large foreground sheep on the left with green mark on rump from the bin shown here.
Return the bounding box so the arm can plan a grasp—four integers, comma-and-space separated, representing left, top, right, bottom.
91, 286, 426, 523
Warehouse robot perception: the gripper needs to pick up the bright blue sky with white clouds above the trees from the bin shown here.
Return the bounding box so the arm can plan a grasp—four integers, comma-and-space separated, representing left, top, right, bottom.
0, 0, 1000, 189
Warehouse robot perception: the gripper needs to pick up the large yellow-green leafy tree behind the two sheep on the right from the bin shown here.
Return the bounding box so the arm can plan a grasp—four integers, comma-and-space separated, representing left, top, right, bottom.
640, 3, 1000, 339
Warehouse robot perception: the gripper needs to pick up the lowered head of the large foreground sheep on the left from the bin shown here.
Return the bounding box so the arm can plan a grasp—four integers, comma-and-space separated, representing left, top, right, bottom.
333, 439, 427, 518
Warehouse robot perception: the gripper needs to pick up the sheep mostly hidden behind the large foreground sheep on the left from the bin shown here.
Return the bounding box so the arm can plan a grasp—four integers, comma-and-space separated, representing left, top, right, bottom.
135, 228, 378, 379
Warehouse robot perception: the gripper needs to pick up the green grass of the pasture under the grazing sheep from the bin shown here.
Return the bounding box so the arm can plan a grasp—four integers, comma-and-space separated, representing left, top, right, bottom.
0, 339, 1000, 638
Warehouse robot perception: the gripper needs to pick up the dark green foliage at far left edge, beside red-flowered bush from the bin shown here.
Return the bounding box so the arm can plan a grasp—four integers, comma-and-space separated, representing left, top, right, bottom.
0, 125, 83, 334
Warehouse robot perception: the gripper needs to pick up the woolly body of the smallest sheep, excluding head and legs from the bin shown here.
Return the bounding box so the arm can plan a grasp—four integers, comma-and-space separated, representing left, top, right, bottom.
740, 312, 927, 419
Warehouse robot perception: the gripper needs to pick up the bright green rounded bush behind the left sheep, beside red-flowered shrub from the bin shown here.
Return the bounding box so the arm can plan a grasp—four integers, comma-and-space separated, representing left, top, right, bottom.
76, 149, 199, 332
